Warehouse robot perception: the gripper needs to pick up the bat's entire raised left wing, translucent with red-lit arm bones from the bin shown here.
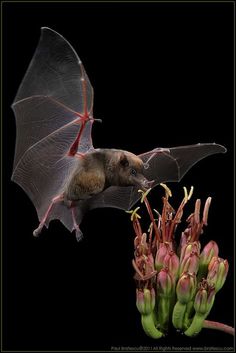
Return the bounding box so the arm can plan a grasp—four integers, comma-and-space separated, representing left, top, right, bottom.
12, 27, 93, 223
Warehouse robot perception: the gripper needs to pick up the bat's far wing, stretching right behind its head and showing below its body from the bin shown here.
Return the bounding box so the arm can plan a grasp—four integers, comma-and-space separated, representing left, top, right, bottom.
90, 143, 226, 210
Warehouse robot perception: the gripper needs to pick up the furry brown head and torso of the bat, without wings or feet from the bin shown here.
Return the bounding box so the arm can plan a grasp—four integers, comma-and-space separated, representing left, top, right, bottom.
64, 149, 149, 201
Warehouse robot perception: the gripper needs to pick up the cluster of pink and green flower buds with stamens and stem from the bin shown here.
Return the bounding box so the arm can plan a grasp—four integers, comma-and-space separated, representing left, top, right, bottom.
129, 184, 234, 338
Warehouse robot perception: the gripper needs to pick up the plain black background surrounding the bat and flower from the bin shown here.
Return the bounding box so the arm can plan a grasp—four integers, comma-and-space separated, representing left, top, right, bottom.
2, 2, 234, 351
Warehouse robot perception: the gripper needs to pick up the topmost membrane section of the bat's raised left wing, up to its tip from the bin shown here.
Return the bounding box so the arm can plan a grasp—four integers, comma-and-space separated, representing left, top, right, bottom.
14, 27, 93, 113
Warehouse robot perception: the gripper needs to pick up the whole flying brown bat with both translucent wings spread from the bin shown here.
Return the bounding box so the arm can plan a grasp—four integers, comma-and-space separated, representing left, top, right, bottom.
12, 27, 226, 240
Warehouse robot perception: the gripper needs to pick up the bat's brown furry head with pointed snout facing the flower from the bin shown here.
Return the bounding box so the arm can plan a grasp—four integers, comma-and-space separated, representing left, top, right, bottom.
117, 151, 153, 190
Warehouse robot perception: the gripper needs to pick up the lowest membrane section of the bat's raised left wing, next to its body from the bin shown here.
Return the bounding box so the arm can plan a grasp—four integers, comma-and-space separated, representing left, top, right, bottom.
12, 107, 78, 219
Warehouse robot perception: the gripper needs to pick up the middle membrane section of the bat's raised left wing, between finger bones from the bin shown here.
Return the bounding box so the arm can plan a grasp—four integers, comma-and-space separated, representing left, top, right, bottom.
13, 96, 81, 169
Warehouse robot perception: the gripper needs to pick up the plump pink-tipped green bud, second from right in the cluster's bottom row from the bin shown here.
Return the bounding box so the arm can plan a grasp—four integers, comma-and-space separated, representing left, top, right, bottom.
176, 272, 197, 304
